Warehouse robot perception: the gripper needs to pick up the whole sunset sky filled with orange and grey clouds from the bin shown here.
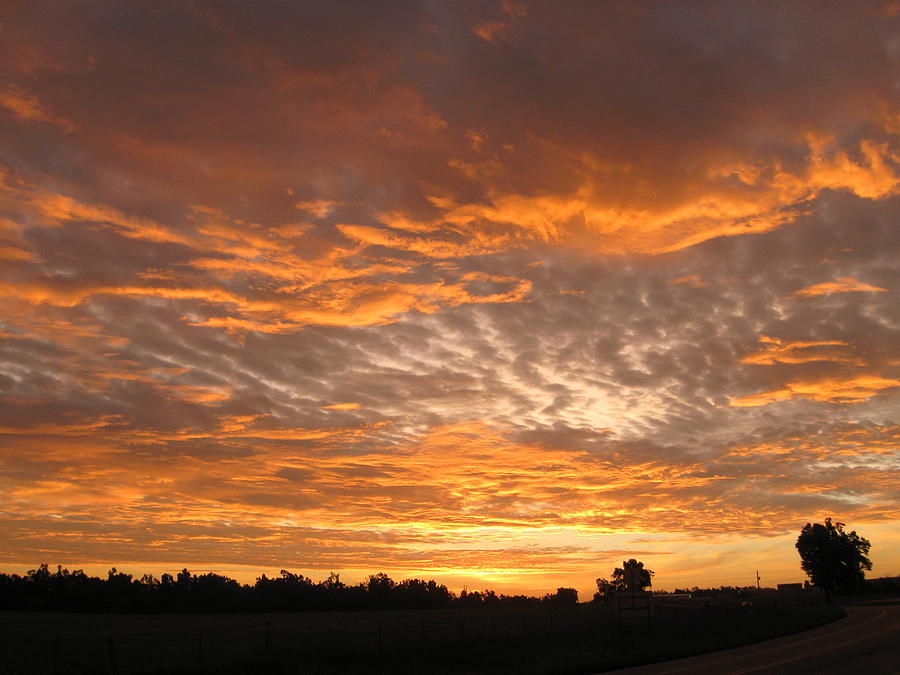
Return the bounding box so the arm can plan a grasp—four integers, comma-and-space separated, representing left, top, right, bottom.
0, 0, 900, 599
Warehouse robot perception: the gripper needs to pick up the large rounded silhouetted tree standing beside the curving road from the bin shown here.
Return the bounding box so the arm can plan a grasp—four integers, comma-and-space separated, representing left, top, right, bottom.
797, 518, 872, 601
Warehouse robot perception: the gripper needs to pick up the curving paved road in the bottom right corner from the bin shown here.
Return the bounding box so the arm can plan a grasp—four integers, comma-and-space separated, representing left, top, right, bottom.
614, 604, 900, 675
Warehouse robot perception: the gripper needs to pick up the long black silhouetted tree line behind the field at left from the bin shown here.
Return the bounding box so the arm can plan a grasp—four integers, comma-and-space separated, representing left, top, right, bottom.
0, 565, 578, 612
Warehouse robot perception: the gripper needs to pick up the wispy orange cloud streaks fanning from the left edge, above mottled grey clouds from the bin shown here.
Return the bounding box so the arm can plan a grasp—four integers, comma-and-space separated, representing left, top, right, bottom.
0, 180, 530, 333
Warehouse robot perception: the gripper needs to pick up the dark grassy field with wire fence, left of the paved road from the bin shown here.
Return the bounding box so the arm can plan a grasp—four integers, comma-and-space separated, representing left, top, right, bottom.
0, 604, 843, 674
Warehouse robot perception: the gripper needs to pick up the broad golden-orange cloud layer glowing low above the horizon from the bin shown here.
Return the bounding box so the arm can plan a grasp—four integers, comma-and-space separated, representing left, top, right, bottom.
0, 416, 898, 589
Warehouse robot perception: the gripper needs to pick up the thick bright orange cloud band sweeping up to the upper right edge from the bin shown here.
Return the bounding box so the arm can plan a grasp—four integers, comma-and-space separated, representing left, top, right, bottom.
378, 139, 900, 255
